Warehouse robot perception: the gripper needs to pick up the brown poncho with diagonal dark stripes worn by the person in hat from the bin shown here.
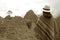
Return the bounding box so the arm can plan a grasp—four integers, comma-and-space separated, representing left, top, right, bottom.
35, 16, 57, 40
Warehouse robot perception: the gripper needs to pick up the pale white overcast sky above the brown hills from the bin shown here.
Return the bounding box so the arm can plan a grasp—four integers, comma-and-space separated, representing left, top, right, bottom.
0, 0, 60, 17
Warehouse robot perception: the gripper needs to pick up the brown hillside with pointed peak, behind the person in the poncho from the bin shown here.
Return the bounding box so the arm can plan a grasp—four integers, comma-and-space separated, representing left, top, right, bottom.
0, 10, 60, 40
